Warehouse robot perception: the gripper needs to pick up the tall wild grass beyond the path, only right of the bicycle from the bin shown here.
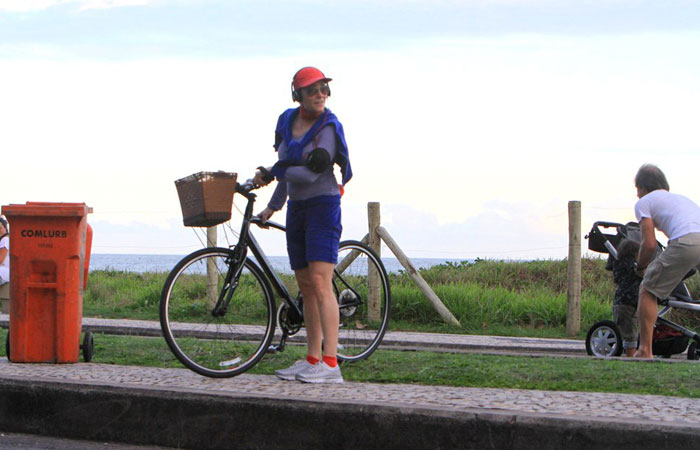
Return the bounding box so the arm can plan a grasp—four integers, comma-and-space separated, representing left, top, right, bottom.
391, 258, 700, 338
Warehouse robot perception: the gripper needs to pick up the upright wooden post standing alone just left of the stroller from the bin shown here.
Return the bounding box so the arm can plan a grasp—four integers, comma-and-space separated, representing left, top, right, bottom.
566, 201, 581, 336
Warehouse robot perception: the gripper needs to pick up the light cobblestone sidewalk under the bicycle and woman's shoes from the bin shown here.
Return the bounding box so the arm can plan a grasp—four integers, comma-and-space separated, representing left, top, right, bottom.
0, 358, 700, 431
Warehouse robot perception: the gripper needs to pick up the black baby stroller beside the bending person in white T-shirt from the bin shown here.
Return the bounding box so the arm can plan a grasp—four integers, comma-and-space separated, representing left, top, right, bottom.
586, 222, 700, 360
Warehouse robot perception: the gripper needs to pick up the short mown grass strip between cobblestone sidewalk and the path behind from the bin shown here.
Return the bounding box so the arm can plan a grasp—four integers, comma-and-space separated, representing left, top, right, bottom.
5, 330, 700, 398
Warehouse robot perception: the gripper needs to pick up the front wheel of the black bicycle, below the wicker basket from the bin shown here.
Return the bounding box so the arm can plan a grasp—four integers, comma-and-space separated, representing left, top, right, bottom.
160, 248, 275, 378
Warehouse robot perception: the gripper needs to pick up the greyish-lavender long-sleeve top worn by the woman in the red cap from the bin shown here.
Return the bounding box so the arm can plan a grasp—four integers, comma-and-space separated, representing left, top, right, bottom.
267, 126, 340, 211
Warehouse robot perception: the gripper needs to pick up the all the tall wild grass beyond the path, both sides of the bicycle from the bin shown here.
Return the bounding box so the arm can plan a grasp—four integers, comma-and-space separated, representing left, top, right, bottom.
83, 258, 700, 338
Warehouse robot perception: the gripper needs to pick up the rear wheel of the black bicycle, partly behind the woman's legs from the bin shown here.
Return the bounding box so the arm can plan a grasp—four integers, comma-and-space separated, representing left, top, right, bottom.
333, 241, 391, 361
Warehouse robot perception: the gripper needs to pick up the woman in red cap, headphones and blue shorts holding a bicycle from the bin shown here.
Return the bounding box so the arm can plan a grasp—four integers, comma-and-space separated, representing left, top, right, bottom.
253, 67, 352, 383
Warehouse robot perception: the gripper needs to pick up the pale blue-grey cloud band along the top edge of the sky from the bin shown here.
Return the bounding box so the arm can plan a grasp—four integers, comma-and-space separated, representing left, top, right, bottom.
5, 0, 700, 59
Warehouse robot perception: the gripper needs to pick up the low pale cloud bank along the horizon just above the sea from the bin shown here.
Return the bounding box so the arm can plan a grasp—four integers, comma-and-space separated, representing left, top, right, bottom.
83, 203, 568, 259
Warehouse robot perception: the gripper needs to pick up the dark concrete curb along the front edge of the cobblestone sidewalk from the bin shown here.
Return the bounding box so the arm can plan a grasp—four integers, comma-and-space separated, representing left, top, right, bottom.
0, 377, 700, 450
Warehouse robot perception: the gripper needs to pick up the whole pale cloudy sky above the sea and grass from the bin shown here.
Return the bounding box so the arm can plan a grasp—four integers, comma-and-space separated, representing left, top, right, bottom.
0, 0, 700, 259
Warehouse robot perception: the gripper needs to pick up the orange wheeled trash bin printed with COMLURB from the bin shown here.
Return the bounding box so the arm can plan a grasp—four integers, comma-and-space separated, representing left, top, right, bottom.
2, 202, 93, 363
